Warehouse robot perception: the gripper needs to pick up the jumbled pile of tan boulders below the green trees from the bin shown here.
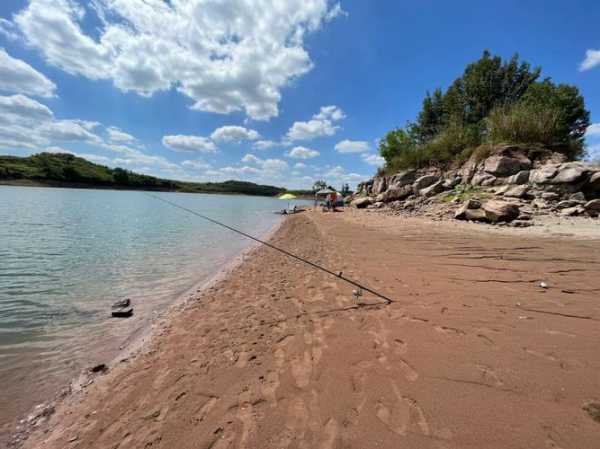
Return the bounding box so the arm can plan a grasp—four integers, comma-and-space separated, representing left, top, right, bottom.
351, 145, 600, 226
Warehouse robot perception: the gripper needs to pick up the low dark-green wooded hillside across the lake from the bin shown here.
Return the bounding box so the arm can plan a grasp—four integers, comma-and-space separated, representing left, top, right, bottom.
0, 153, 285, 196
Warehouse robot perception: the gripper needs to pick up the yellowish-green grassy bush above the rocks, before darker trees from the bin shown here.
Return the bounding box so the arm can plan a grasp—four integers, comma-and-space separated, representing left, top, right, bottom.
485, 103, 560, 146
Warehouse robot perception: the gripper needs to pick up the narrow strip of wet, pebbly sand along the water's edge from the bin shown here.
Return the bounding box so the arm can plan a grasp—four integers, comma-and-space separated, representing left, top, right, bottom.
8, 218, 283, 447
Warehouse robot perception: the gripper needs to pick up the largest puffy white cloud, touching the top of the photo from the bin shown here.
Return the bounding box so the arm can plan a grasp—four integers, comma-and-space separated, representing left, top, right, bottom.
10, 0, 343, 120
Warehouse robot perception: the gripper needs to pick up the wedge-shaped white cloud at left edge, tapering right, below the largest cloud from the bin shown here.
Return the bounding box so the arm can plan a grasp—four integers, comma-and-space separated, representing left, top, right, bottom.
0, 48, 56, 97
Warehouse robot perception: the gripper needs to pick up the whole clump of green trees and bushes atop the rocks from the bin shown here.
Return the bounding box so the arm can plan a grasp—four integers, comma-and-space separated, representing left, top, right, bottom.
379, 51, 590, 172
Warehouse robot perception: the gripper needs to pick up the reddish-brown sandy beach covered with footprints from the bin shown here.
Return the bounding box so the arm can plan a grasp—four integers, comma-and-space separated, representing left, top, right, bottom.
18, 211, 600, 449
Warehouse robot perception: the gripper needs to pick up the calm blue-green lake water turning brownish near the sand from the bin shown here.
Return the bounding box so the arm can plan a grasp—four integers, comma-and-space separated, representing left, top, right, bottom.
0, 186, 300, 438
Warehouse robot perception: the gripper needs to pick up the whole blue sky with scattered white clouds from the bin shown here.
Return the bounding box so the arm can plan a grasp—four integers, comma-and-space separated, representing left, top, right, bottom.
0, 0, 600, 188
